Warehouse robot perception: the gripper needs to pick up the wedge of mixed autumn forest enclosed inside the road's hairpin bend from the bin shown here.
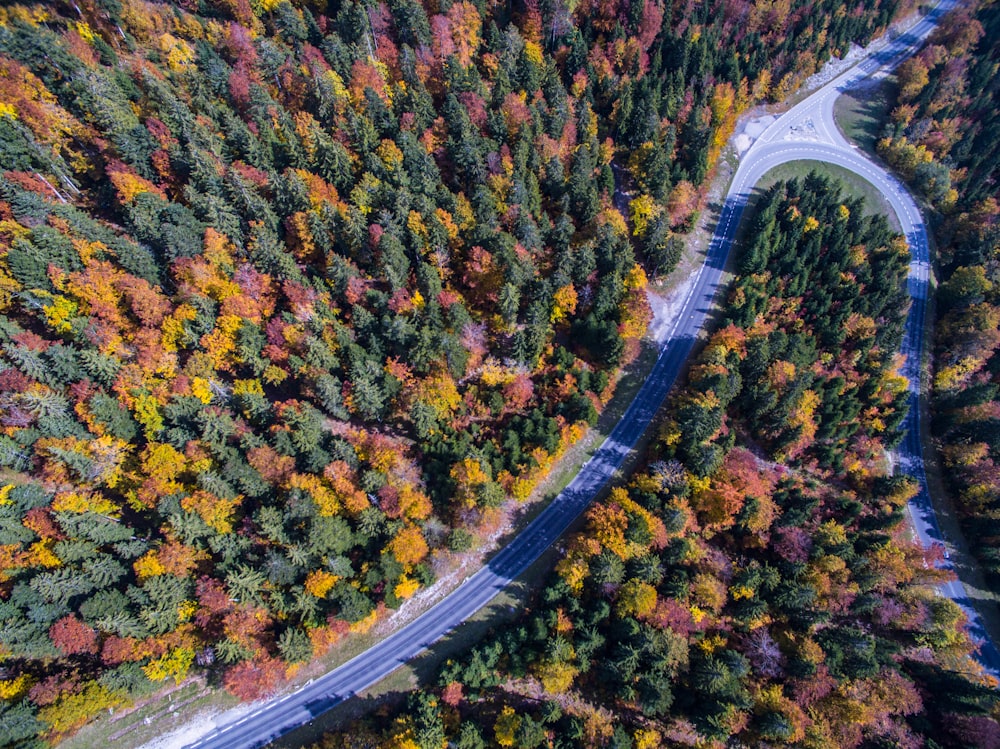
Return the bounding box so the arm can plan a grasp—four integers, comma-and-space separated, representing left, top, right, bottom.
304, 174, 1000, 749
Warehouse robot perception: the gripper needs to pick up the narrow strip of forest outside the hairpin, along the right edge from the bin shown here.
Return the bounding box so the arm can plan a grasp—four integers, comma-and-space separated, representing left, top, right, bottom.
879, 3, 1000, 590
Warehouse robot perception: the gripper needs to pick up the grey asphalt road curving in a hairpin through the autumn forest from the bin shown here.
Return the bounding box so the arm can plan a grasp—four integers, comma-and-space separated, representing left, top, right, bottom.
189, 0, 1000, 749
